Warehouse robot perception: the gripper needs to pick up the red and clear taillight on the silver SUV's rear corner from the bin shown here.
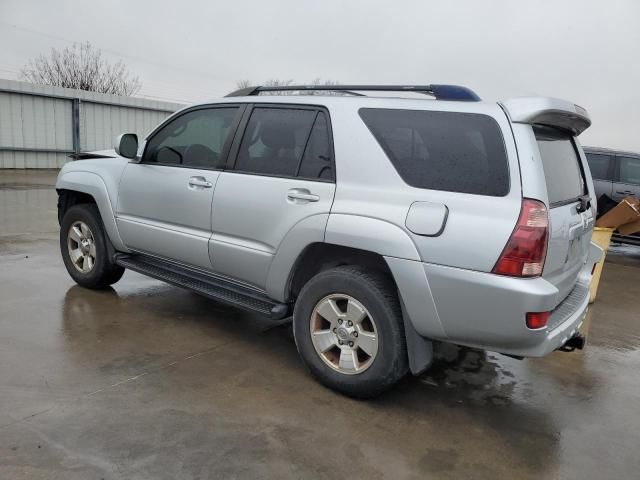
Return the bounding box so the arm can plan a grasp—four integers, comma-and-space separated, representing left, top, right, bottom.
492, 198, 549, 277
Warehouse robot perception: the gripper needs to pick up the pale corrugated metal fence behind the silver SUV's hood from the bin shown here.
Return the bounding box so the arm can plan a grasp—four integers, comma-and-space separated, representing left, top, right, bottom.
0, 79, 183, 168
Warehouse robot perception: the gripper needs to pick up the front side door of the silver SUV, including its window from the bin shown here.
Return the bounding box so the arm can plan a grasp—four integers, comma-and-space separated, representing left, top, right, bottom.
116, 105, 240, 270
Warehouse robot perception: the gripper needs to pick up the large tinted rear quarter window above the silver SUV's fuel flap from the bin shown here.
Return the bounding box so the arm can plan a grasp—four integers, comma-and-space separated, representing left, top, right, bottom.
360, 108, 509, 196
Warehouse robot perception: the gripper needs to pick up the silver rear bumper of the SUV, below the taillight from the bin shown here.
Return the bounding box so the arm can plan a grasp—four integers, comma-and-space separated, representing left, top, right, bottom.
388, 259, 591, 357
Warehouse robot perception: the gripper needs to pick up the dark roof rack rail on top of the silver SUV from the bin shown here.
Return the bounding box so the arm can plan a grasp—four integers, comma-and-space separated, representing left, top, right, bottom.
227, 85, 480, 102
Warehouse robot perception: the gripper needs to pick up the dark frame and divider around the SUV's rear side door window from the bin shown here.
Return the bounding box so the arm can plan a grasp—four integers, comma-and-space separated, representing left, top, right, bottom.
225, 102, 337, 183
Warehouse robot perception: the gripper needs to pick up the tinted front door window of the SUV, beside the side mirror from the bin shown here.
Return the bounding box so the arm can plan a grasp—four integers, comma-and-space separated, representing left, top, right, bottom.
143, 107, 238, 168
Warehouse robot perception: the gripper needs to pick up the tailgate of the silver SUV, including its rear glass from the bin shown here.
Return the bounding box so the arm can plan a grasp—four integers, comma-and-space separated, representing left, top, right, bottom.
533, 126, 595, 298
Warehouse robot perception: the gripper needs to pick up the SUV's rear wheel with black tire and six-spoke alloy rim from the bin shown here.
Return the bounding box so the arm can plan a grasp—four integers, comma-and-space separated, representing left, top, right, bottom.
293, 266, 408, 398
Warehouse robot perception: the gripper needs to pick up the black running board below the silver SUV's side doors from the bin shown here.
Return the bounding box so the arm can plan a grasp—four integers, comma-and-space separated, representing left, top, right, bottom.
115, 253, 290, 320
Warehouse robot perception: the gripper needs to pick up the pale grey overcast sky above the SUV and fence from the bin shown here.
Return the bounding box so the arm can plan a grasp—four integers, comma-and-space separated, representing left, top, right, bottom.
0, 0, 640, 151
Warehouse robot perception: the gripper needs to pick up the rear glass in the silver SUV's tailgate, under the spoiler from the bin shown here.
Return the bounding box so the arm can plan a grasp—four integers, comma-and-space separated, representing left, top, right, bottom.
533, 127, 586, 204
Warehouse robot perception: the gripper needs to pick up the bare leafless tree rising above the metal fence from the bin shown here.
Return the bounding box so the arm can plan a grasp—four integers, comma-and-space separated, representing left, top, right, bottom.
20, 42, 141, 96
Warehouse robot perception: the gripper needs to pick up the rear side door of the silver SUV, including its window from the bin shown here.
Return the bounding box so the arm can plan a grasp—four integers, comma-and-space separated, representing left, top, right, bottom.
210, 105, 335, 289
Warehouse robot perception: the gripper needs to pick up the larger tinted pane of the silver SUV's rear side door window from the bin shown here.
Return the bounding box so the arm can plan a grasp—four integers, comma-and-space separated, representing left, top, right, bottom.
236, 107, 316, 177
